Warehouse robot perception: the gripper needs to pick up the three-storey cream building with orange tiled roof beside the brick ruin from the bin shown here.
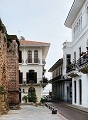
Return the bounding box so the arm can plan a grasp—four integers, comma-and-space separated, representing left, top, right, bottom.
19, 40, 50, 102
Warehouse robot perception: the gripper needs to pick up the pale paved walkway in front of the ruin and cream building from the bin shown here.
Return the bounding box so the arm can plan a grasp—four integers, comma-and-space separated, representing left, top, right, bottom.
0, 105, 67, 120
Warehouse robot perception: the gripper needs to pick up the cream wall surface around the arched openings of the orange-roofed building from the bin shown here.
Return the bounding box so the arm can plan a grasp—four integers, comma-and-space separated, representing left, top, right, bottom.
19, 46, 43, 102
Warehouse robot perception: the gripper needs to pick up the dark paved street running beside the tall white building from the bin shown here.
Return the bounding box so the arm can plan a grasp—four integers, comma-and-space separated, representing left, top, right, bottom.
48, 103, 88, 120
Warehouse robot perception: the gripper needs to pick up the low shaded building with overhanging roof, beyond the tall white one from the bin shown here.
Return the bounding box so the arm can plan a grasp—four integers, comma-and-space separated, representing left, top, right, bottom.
49, 58, 72, 102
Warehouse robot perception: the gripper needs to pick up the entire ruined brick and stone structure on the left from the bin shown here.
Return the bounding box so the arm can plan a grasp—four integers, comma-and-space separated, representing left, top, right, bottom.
0, 20, 20, 114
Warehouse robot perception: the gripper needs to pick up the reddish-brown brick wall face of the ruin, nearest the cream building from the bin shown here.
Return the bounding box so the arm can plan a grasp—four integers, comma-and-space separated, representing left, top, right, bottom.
7, 39, 19, 105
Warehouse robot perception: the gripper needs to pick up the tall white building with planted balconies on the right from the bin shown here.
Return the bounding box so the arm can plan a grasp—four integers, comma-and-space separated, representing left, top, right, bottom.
63, 0, 88, 108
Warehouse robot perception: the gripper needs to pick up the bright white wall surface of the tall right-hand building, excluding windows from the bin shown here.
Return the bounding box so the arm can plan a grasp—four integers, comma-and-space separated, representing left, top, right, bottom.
63, 0, 88, 107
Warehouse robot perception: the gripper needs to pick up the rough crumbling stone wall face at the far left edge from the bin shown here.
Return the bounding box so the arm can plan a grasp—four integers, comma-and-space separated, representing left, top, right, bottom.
0, 31, 8, 114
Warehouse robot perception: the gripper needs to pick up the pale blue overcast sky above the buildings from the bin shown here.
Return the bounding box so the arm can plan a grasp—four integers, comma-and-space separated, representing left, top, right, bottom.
0, 0, 73, 92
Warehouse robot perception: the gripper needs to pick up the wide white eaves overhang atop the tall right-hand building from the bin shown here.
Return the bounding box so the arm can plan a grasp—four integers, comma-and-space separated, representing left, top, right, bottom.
64, 0, 86, 28
